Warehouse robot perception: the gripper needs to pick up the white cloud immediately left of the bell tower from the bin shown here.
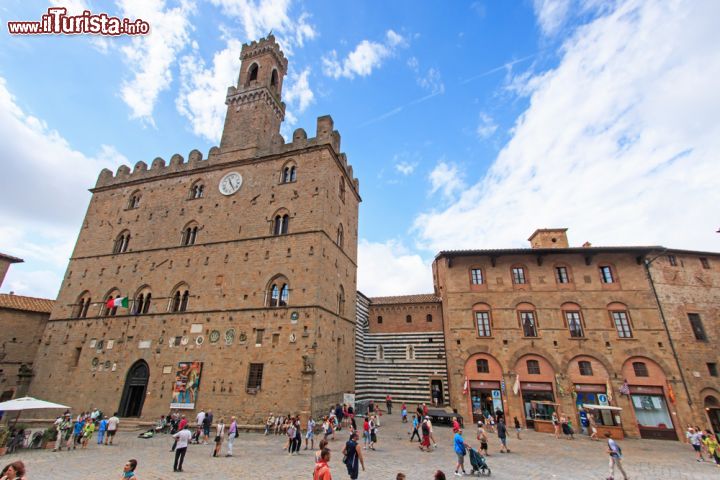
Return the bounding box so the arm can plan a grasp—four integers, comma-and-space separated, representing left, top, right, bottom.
175, 38, 242, 142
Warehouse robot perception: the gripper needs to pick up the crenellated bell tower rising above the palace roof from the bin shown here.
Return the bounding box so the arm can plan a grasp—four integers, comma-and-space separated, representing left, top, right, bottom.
220, 34, 288, 155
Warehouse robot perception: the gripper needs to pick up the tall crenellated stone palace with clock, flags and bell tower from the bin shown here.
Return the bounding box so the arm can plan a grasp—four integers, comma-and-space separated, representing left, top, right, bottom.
31, 35, 360, 422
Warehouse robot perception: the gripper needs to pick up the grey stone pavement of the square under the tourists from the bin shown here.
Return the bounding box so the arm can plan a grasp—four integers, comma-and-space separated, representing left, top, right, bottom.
0, 417, 720, 480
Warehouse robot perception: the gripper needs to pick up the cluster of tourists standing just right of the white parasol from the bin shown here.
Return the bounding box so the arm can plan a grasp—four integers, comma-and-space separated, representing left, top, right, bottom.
53, 409, 120, 451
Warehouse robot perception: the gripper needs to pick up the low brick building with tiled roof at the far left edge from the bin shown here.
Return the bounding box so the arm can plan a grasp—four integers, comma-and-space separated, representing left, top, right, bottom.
0, 253, 55, 402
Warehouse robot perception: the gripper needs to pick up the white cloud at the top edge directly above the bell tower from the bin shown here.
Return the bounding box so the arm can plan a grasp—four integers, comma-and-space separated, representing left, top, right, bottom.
210, 0, 317, 55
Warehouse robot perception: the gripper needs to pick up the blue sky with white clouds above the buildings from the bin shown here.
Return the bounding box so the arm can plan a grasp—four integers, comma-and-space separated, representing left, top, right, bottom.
0, 0, 720, 297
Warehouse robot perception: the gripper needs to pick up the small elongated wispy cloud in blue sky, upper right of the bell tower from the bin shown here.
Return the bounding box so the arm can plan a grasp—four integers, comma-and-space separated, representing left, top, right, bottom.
322, 30, 407, 79
